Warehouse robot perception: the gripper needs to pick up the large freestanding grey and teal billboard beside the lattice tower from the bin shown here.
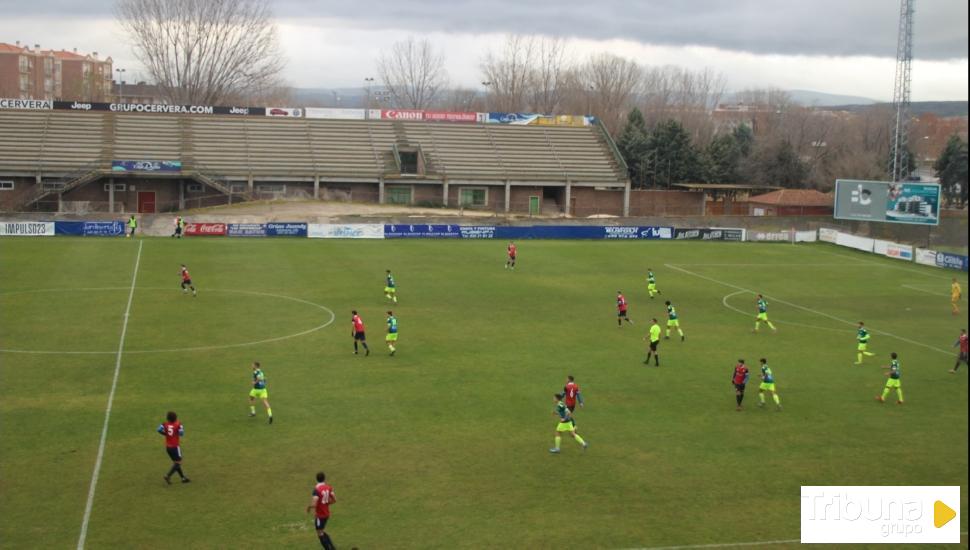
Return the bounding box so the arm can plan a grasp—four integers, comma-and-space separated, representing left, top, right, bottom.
835, 180, 940, 225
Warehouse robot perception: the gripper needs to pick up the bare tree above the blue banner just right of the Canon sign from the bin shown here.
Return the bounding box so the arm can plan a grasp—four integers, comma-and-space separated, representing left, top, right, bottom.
482, 34, 535, 112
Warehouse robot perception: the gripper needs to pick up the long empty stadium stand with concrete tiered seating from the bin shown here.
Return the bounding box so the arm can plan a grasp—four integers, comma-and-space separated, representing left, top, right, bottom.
0, 110, 629, 215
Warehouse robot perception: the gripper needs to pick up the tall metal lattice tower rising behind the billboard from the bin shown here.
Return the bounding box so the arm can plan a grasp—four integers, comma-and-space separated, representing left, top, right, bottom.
889, 0, 915, 182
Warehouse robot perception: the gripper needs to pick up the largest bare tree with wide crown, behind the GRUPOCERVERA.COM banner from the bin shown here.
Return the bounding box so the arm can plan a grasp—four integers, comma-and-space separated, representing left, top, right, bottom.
116, 0, 284, 105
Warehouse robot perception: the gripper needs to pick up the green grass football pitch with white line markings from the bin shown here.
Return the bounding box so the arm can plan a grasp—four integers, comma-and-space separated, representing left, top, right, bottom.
0, 238, 968, 550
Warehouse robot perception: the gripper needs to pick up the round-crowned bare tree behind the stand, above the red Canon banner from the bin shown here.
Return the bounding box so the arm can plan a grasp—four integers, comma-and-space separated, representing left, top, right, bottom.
377, 37, 448, 109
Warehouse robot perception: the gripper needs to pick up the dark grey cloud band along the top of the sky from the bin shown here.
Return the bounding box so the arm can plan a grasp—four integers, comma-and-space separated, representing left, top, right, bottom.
6, 0, 968, 59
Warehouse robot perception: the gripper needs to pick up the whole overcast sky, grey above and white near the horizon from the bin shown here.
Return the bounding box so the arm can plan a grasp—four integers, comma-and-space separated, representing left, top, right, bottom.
0, 0, 968, 101
